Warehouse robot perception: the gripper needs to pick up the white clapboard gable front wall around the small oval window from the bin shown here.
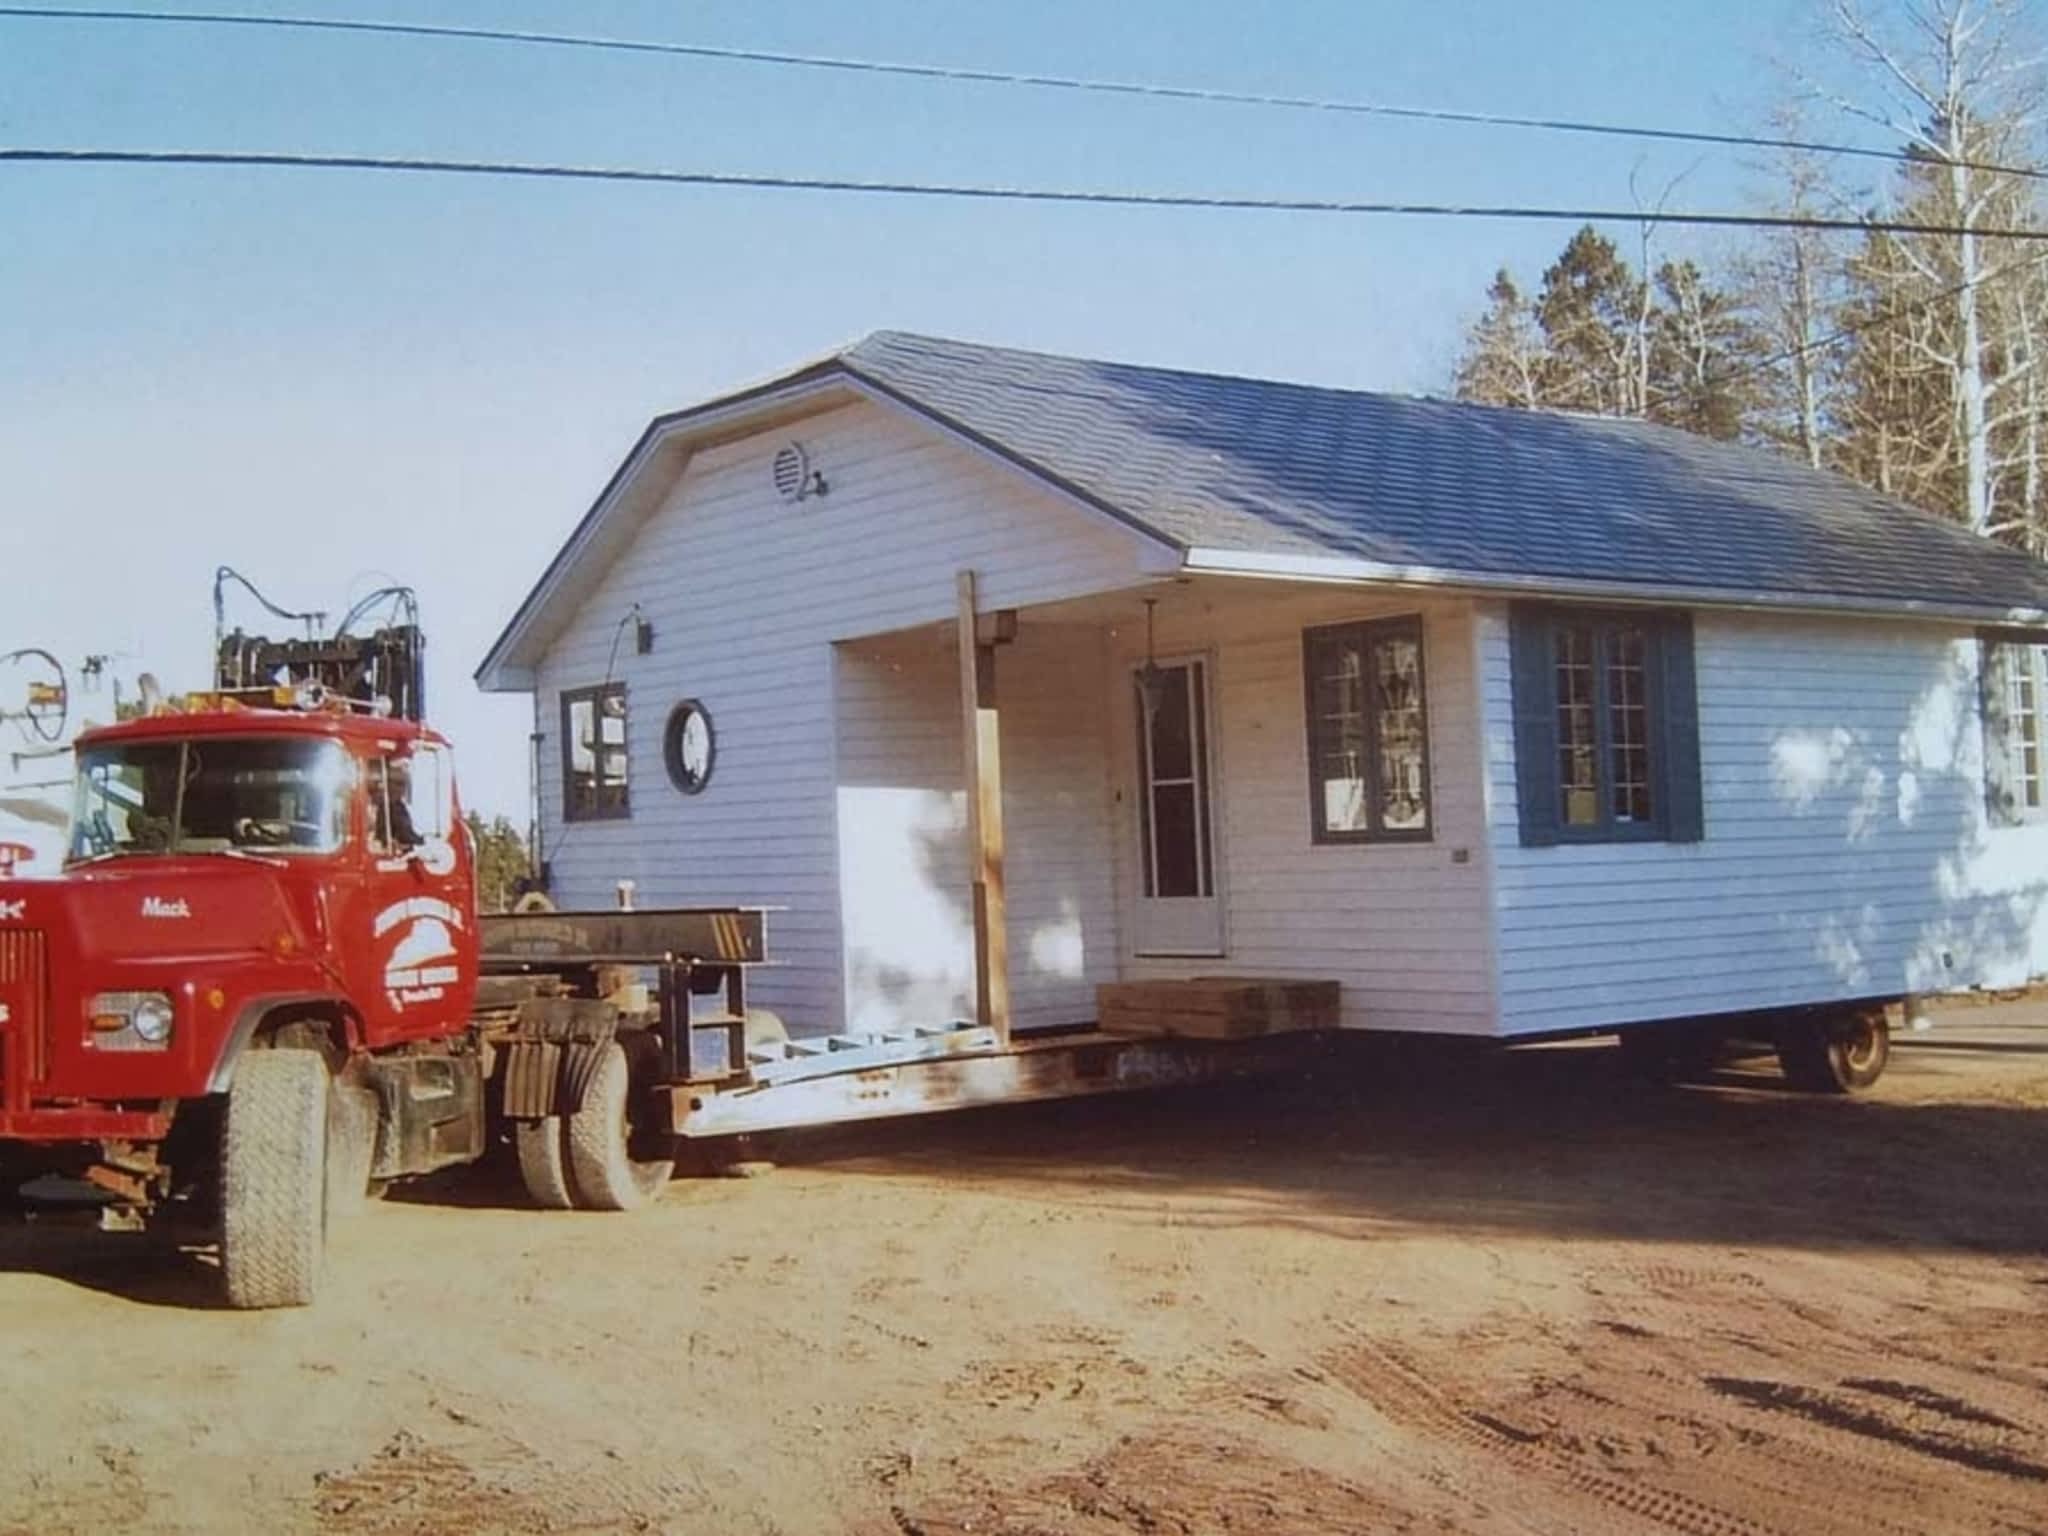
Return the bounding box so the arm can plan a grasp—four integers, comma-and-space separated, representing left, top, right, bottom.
535, 403, 1141, 1032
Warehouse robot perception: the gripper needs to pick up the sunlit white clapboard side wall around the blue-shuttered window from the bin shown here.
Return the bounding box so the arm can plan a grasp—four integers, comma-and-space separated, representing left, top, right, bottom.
1479, 604, 2048, 1034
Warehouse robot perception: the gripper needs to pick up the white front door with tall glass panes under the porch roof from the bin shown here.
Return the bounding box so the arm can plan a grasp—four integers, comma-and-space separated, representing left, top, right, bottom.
1133, 659, 1223, 954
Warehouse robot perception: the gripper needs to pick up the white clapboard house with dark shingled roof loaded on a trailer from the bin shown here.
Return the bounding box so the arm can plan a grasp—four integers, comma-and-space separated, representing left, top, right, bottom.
477, 334, 2048, 1036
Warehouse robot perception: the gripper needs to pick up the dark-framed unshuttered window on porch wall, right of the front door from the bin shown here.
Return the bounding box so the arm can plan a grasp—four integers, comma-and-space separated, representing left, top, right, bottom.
1303, 618, 1430, 842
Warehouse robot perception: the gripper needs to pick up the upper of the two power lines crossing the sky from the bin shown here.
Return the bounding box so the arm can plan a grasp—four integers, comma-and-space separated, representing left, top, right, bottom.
12, 4, 2048, 190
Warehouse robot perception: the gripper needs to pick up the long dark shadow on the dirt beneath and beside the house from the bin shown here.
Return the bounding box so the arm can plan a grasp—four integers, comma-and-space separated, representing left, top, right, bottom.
762, 1032, 2048, 1255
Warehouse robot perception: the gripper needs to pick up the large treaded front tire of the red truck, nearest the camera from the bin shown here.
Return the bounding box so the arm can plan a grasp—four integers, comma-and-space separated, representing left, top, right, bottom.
221, 1051, 328, 1307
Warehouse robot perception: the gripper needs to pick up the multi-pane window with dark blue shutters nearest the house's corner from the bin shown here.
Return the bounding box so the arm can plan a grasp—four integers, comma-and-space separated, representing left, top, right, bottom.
1511, 604, 1704, 844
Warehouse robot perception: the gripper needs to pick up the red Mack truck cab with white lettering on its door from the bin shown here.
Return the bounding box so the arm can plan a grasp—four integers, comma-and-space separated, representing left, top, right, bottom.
0, 688, 481, 1305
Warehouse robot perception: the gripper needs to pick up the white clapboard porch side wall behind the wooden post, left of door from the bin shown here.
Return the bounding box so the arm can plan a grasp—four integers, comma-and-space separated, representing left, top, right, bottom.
838, 621, 1116, 1030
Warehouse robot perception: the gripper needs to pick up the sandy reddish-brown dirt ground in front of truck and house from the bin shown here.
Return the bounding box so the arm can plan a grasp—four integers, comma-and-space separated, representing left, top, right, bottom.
0, 1006, 2048, 1536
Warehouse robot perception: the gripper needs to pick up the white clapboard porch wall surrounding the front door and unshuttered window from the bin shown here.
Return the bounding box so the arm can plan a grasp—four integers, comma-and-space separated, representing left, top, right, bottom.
1108, 582, 1493, 1034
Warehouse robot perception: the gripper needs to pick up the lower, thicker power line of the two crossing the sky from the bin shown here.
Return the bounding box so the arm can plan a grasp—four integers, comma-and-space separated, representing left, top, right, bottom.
12, 147, 2048, 242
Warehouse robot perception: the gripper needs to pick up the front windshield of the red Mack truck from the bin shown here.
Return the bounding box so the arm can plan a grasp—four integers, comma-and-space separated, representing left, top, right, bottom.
72, 737, 350, 858
